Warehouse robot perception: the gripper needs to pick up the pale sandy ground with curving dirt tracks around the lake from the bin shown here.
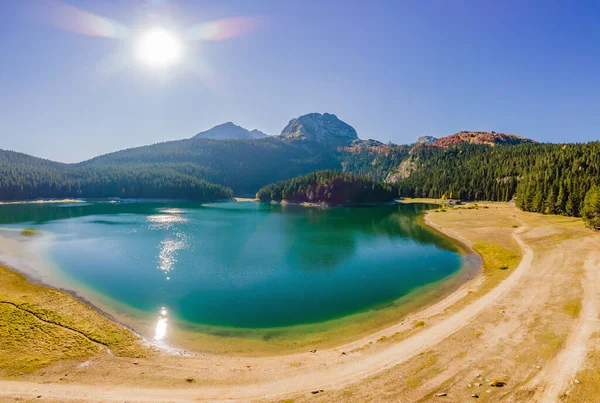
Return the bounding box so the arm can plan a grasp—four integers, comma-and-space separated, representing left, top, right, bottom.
0, 203, 600, 402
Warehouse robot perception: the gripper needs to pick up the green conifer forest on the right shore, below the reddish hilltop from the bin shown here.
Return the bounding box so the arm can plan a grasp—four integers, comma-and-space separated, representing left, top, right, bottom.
398, 142, 600, 216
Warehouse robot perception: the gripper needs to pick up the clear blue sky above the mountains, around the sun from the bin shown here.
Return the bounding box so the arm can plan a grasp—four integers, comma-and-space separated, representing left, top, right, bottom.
0, 0, 600, 162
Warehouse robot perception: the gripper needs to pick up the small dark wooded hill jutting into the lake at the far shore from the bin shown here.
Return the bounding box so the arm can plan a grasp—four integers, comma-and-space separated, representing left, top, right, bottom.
256, 171, 398, 205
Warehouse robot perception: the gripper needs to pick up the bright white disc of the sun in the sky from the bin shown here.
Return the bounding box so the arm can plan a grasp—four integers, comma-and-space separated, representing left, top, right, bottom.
137, 28, 182, 67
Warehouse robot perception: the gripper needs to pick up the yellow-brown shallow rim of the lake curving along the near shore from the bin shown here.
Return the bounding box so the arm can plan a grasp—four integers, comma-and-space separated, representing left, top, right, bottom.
0, 201, 482, 356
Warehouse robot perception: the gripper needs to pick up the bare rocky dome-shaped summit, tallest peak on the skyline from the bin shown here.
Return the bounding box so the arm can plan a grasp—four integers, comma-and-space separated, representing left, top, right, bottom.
281, 113, 358, 147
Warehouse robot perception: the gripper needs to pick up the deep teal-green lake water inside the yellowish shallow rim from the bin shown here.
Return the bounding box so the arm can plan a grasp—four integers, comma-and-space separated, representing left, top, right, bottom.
0, 202, 462, 328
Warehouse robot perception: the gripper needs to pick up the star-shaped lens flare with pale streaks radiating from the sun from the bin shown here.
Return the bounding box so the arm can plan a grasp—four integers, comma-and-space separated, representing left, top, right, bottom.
32, 0, 267, 80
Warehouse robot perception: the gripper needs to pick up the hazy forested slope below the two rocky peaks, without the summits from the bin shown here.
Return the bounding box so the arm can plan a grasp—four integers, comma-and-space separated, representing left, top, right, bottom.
79, 138, 339, 195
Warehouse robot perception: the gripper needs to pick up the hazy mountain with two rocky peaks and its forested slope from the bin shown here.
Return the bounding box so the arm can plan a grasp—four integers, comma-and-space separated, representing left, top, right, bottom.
80, 113, 359, 195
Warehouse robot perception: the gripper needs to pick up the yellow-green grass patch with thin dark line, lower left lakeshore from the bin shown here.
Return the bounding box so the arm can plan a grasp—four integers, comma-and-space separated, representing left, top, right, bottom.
0, 266, 147, 376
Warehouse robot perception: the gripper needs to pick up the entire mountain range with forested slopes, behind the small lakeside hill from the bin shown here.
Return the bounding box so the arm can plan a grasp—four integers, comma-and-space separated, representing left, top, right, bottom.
0, 113, 600, 224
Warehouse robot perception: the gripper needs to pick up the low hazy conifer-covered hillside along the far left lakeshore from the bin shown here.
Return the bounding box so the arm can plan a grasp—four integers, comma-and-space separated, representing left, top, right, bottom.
0, 150, 233, 201
